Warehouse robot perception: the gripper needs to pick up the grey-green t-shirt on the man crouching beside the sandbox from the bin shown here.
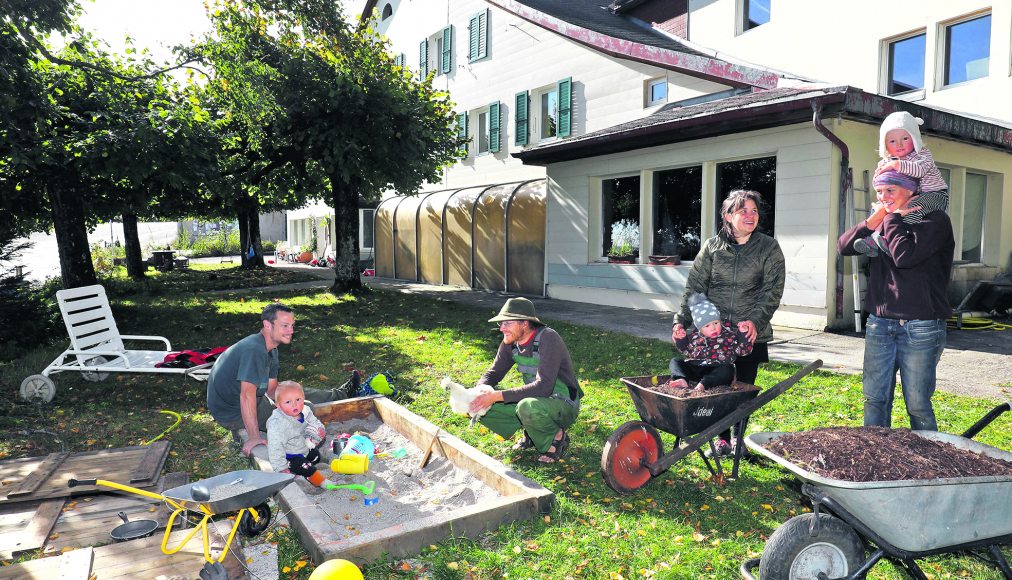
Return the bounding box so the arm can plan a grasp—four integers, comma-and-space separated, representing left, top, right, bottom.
207, 332, 278, 423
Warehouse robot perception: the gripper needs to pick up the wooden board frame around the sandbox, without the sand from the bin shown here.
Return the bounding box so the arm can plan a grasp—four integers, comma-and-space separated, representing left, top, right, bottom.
253, 396, 555, 564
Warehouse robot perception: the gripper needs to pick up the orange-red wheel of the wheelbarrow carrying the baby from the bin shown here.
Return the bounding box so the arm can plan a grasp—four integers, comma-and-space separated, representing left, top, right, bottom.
601, 421, 664, 494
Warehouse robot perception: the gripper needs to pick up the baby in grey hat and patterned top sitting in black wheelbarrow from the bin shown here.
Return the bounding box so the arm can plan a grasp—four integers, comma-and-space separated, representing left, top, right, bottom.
668, 294, 752, 392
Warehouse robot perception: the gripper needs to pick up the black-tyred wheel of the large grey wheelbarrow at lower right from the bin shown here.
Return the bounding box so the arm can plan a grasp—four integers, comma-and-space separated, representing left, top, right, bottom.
759, 513, 864, 580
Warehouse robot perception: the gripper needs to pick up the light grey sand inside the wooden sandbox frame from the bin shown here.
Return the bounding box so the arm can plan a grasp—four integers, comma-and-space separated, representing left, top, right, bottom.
297, 418, 499, 540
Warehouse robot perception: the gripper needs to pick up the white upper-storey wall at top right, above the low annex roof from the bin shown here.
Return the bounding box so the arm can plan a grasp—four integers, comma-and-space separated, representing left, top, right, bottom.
689, 0, 1012, 121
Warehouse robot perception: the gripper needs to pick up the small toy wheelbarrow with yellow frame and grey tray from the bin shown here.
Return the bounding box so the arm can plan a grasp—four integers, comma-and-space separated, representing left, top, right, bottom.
67, 470, 296, 562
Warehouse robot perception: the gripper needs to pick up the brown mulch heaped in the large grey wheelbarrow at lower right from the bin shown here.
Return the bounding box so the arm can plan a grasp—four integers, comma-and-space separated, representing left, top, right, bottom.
766, 427, 1012, 482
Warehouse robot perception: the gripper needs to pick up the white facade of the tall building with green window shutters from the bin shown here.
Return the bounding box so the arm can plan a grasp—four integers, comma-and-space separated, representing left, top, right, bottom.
376, 0, 729, 190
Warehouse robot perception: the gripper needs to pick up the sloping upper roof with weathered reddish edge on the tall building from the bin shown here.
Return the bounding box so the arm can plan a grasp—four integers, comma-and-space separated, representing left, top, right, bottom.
362, 0, 779, 89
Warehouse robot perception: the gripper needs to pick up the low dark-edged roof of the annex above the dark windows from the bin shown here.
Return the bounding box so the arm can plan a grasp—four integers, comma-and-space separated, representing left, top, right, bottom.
513, 85, 1012, 165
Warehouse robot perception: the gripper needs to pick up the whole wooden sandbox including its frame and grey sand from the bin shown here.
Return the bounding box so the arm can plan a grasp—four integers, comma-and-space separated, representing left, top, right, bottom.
254, 397, 555, 563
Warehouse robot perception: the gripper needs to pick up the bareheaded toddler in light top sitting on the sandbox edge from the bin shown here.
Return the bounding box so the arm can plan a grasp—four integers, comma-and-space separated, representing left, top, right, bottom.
267, 381, 335, 489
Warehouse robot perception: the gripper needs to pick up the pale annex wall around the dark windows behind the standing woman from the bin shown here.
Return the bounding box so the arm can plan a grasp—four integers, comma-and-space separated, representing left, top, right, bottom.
546, 123, 837, 330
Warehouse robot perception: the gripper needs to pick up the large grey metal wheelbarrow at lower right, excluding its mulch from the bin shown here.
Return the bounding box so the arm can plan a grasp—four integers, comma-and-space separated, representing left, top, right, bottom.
741, 403, 1012, 580
